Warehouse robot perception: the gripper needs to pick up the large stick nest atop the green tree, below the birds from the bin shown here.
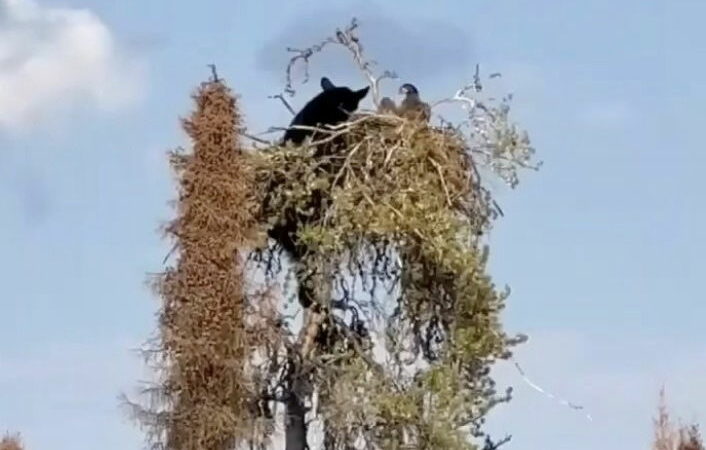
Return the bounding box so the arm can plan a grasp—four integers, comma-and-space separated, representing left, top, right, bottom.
256, 115, 497, 253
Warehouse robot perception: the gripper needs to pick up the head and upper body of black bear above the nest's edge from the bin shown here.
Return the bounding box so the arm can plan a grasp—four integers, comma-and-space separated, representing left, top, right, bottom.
284, 77, 370, 145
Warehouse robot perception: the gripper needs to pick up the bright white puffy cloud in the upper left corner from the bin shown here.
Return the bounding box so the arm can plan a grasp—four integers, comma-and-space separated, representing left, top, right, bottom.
0, 0, 143, 128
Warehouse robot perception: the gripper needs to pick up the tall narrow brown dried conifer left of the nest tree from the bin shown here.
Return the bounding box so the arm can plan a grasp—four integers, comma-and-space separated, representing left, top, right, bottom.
134, 81, 270, 450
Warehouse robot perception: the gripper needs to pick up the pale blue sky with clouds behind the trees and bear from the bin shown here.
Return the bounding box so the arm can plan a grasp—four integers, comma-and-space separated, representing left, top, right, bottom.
0, 0, 706, 450
